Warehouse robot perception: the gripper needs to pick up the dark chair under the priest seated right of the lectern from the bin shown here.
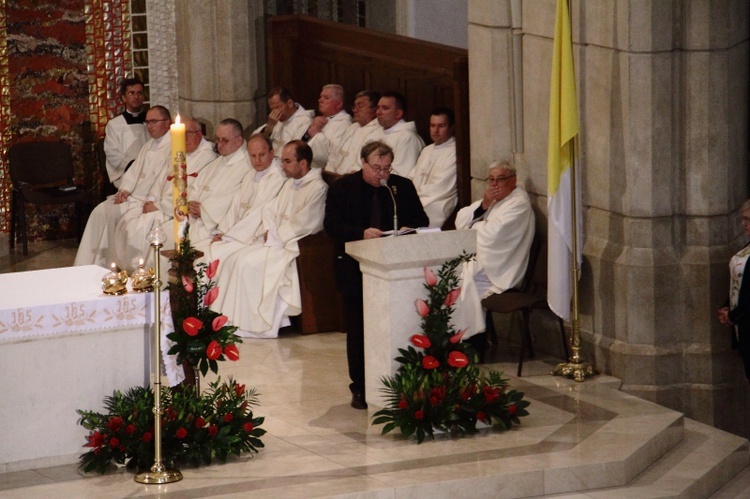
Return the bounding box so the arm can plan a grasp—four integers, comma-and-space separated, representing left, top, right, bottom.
482, 235, 569, 377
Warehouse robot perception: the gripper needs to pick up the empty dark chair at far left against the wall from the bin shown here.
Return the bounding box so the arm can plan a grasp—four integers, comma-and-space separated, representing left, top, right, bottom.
8, 141, 86, 255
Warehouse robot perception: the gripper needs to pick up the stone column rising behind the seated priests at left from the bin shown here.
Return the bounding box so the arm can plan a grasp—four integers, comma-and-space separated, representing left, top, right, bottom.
176, 0, 265, 137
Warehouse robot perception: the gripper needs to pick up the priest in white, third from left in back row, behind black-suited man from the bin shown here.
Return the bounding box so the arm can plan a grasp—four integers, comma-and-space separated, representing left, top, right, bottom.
325, 90, 383, 175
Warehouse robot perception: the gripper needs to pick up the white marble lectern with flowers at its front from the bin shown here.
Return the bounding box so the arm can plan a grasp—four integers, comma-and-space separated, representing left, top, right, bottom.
346, 230, 476, 408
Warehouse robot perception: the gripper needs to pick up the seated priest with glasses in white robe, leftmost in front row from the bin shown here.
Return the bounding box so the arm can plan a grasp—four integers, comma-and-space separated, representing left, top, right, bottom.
74, 106, 172, 267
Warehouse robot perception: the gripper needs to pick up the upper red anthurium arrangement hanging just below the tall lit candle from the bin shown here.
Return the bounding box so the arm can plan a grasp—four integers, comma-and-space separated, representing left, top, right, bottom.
167, 236, 242, 376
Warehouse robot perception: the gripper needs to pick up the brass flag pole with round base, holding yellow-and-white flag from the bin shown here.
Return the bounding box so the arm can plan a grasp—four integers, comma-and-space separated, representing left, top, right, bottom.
552, 135, 598, 382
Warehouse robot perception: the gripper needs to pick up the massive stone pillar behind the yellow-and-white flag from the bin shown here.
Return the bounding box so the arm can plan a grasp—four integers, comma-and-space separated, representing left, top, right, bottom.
469, 0, 750, 436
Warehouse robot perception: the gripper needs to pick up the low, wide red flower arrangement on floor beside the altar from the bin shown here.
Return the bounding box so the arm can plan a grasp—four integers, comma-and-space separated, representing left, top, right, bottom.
78, 378, 266, 473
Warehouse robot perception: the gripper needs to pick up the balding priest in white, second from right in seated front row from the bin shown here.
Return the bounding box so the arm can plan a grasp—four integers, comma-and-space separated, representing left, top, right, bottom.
192, 133, 286, 263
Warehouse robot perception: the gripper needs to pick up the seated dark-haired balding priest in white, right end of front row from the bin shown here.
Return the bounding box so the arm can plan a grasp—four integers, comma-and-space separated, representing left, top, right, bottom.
212, 140, 328, 338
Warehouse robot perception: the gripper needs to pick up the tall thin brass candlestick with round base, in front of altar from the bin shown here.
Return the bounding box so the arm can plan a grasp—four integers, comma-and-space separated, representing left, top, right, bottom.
135, 224, 182, 484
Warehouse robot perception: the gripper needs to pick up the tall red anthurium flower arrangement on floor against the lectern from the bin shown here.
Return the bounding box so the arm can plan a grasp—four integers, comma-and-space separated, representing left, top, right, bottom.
373, 254, 529, 443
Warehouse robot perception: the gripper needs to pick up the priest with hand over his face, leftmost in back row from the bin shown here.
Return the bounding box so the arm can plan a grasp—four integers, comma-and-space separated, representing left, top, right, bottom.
253, 87, 315, 157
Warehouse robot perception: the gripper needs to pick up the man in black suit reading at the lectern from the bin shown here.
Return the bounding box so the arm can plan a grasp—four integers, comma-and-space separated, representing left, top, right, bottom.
324, 142, 429, 409
